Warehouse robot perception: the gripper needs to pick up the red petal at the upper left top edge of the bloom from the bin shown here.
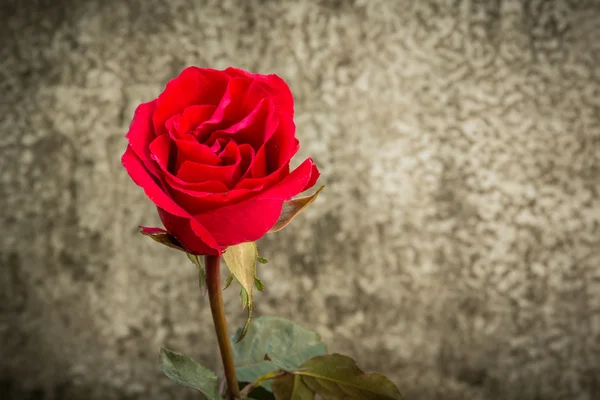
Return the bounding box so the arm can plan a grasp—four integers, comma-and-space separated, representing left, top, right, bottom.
152, 67, 230, 134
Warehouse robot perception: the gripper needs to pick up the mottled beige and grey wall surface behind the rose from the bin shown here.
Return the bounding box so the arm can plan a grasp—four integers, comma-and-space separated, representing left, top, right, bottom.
0, 0, 600, 400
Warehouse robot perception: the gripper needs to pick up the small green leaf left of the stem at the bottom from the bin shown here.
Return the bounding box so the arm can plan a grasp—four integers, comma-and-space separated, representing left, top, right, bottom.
160, 348, 223, 400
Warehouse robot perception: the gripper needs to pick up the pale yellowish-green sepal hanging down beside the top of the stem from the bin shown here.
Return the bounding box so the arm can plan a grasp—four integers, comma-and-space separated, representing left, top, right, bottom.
223, 242, 258, 342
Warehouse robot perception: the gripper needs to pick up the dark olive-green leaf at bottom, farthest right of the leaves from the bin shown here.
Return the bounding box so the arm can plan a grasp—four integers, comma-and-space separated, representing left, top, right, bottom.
294, 354, 402, 400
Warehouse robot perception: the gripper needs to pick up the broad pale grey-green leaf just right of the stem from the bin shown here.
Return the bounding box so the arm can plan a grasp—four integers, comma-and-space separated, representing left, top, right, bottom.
233, 317, 327, 390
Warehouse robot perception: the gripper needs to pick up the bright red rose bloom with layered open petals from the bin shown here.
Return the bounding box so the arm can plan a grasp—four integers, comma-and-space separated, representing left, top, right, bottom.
122, 67, 319, 254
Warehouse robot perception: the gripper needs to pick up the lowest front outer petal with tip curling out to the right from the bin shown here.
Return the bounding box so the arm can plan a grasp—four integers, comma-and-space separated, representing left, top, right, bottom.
195, 159, 313, 248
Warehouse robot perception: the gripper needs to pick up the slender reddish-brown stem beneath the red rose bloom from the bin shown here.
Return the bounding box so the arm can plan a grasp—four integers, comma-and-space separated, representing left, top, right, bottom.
204, 255, 240, 399
